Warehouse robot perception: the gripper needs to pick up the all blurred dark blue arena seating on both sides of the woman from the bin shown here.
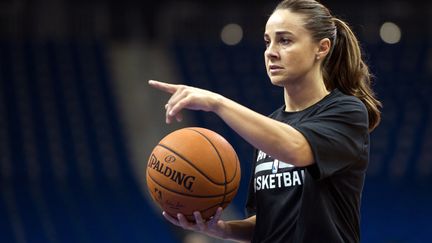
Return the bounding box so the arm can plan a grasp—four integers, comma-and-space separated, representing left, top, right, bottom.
0, 36, 432, 243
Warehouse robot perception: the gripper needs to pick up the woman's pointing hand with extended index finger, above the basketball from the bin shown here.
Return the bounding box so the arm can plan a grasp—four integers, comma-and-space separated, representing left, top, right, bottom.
149, 80, 220, 123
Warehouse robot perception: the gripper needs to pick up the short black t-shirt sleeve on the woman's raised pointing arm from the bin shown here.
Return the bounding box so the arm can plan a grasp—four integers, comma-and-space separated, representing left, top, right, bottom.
292, 96, 369, 179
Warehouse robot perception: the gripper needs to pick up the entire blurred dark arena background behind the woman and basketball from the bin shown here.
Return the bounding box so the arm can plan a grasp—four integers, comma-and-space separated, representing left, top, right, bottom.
0, 0, 432, 243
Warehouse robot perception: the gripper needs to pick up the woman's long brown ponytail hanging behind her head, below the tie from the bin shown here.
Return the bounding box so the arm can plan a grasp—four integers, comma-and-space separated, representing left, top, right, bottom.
323, 18, 382, 131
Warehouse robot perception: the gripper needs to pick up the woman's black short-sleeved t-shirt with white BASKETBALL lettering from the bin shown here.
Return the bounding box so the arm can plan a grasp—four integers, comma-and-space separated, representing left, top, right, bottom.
246, 89, 369, 243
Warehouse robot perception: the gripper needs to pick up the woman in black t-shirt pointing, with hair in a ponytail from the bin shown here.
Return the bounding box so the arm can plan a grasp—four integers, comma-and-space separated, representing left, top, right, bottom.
149, 0, 381, 243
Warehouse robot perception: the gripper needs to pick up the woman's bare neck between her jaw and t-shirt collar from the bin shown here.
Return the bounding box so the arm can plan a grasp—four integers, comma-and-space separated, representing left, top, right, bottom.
284, 77, 330, 112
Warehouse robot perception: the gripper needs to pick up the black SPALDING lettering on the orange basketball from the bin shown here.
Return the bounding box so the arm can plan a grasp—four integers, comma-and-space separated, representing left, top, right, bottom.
148, 154, 195, 191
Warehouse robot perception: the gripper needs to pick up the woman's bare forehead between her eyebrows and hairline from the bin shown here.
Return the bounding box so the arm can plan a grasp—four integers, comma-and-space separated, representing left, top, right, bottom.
264, 9, 307, 35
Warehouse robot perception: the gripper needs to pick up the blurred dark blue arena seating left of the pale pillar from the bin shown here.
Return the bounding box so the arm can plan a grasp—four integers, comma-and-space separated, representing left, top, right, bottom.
0, 40, 175, 243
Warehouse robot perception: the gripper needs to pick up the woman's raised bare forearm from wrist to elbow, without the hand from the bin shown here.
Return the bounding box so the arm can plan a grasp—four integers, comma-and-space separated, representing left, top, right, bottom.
214, 96, 313, 166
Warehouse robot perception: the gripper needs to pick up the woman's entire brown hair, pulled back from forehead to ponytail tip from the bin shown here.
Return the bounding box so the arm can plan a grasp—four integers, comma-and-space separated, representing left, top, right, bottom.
275, 0, 382, 131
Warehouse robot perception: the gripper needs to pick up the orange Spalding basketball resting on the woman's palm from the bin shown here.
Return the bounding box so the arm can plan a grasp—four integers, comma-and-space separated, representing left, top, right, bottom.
146, 127, 241, 222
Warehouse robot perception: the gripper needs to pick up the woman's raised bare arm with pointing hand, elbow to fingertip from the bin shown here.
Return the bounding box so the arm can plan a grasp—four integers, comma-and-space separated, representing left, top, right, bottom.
149, 80, 313, 166
